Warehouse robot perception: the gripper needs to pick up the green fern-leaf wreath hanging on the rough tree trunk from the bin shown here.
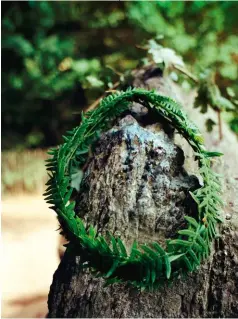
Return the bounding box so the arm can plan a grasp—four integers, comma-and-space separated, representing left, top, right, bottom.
44, 88, 223, 289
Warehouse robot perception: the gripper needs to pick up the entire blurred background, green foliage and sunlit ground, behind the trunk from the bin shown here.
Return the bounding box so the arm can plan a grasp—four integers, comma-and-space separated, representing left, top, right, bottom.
1, 1, 238, 317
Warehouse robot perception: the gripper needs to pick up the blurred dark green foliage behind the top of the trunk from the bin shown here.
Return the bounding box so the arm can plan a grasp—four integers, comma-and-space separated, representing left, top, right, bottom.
2, 1, 238, 149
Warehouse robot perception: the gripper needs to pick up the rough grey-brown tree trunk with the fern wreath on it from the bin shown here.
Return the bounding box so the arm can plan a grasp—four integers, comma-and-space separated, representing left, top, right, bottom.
48, 68, 238, 318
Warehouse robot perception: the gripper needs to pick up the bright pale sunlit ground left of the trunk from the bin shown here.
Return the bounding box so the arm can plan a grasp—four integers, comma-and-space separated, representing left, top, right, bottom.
1, 195, 59, 318
